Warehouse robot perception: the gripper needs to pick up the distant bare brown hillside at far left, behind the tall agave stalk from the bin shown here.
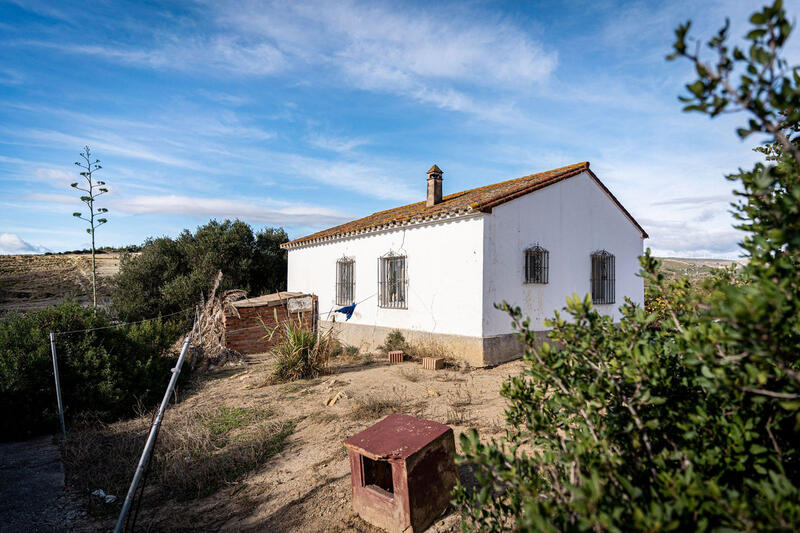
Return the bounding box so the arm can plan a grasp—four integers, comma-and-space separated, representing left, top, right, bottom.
0, 253, 120, 312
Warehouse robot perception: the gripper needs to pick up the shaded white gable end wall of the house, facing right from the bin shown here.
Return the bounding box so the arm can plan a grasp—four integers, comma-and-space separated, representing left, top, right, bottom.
483, 173, 644, 337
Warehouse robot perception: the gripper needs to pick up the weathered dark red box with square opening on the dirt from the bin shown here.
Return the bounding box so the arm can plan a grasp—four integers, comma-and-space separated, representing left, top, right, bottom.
344, 414, 458, 533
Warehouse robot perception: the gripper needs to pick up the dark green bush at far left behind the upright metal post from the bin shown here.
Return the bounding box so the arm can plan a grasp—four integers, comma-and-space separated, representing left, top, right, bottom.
0, 302, 181, 439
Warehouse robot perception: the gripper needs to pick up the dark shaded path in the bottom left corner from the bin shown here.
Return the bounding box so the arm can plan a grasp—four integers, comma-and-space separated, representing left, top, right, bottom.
0, 437, 82, 533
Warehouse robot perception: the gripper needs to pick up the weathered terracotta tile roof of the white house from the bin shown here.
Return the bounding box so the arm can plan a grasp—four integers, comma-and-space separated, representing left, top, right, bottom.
281, 161, 647, 248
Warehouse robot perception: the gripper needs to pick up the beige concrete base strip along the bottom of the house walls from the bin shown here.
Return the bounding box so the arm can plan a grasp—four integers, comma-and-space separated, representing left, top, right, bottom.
319, 320, 547, 366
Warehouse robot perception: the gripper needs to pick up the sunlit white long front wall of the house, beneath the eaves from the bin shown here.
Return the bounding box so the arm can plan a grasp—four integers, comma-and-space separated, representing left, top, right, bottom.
287, 215, 484, 337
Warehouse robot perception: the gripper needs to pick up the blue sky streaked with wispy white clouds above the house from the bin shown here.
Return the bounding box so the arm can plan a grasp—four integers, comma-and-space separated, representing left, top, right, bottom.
0, 0, 800, 257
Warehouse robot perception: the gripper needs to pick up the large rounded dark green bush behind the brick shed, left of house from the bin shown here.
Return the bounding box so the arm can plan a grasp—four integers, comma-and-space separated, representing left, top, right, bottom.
112, 220, 288, 321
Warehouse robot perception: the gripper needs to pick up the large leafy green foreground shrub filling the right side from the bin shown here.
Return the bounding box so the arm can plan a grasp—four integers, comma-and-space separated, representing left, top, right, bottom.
455, 2, 800, 531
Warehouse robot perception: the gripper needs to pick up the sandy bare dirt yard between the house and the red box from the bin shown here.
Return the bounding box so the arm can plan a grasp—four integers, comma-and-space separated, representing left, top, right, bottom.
68, 355, 523, 532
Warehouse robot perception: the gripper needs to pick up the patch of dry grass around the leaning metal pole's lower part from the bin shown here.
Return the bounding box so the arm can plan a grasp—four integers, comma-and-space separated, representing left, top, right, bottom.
64, 407, 294, 515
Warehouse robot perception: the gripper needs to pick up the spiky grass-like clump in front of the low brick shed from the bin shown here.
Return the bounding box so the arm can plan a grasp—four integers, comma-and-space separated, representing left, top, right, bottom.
265, 320, 342, 382
